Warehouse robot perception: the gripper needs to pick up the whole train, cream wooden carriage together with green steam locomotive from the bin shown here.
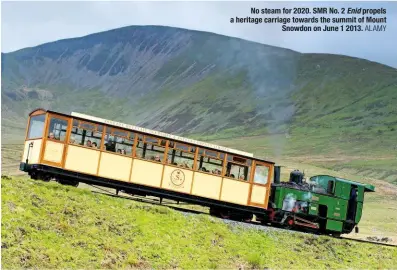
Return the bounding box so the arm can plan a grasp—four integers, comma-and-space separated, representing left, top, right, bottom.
20, 109, 374, 233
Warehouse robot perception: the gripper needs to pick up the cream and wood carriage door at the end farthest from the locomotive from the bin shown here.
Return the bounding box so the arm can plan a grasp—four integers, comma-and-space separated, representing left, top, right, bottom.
42, 114, 69, 167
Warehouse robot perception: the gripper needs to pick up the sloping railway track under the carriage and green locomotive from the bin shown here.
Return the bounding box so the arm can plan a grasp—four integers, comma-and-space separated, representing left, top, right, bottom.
87, 184, 397, 248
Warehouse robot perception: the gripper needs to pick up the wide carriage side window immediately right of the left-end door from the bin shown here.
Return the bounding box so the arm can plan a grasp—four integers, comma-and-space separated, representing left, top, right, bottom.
69, 120, 102, 149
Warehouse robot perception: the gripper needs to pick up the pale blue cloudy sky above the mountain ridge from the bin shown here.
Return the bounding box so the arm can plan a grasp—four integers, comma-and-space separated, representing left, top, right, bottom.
1, 1, 397, 68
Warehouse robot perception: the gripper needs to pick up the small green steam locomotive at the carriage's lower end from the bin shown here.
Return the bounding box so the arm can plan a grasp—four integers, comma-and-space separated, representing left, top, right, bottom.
257, 166, 375, 236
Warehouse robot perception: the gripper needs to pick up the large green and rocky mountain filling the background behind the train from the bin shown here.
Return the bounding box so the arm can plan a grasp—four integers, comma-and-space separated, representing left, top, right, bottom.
1, 26, 397, 181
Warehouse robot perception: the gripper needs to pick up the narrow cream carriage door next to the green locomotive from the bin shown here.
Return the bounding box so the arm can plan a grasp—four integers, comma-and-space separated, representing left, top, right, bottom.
249, 161, 271, 208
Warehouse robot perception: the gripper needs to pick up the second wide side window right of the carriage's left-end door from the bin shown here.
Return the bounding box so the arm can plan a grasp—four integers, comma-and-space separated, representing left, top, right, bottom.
104, 128, 134, 156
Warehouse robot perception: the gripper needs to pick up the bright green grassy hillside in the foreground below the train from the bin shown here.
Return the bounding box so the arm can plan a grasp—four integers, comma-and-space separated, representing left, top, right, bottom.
1, 178, 397, 269
